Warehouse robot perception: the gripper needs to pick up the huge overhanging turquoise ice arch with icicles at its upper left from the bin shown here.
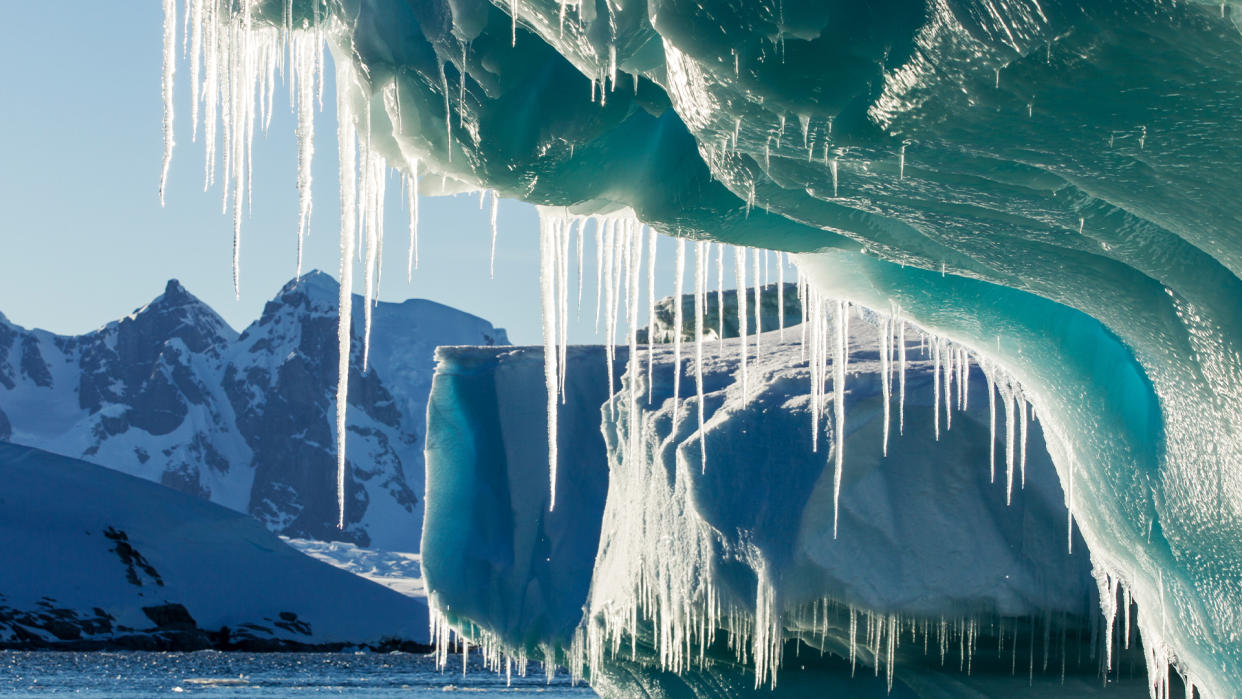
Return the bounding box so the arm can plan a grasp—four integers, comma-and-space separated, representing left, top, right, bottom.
164, 0, 1242, 697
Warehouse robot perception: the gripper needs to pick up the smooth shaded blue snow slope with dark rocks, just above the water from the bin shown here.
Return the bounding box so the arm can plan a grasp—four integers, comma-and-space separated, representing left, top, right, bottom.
0, 443, 427, 643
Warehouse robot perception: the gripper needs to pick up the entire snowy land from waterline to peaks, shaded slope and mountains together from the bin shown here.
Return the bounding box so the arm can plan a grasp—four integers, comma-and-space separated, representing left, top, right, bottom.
0, 272, 508, 651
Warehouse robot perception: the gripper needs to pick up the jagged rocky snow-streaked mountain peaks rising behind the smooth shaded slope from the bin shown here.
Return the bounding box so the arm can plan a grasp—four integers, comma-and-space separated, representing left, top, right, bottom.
0, 272, 508, 551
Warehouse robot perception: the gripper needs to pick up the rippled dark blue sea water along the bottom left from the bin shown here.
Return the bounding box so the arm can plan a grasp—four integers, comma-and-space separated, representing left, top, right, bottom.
0, 651, 595, 698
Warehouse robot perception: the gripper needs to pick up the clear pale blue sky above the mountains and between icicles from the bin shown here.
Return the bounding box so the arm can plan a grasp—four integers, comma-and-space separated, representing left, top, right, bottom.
0, 1, 733, 344
